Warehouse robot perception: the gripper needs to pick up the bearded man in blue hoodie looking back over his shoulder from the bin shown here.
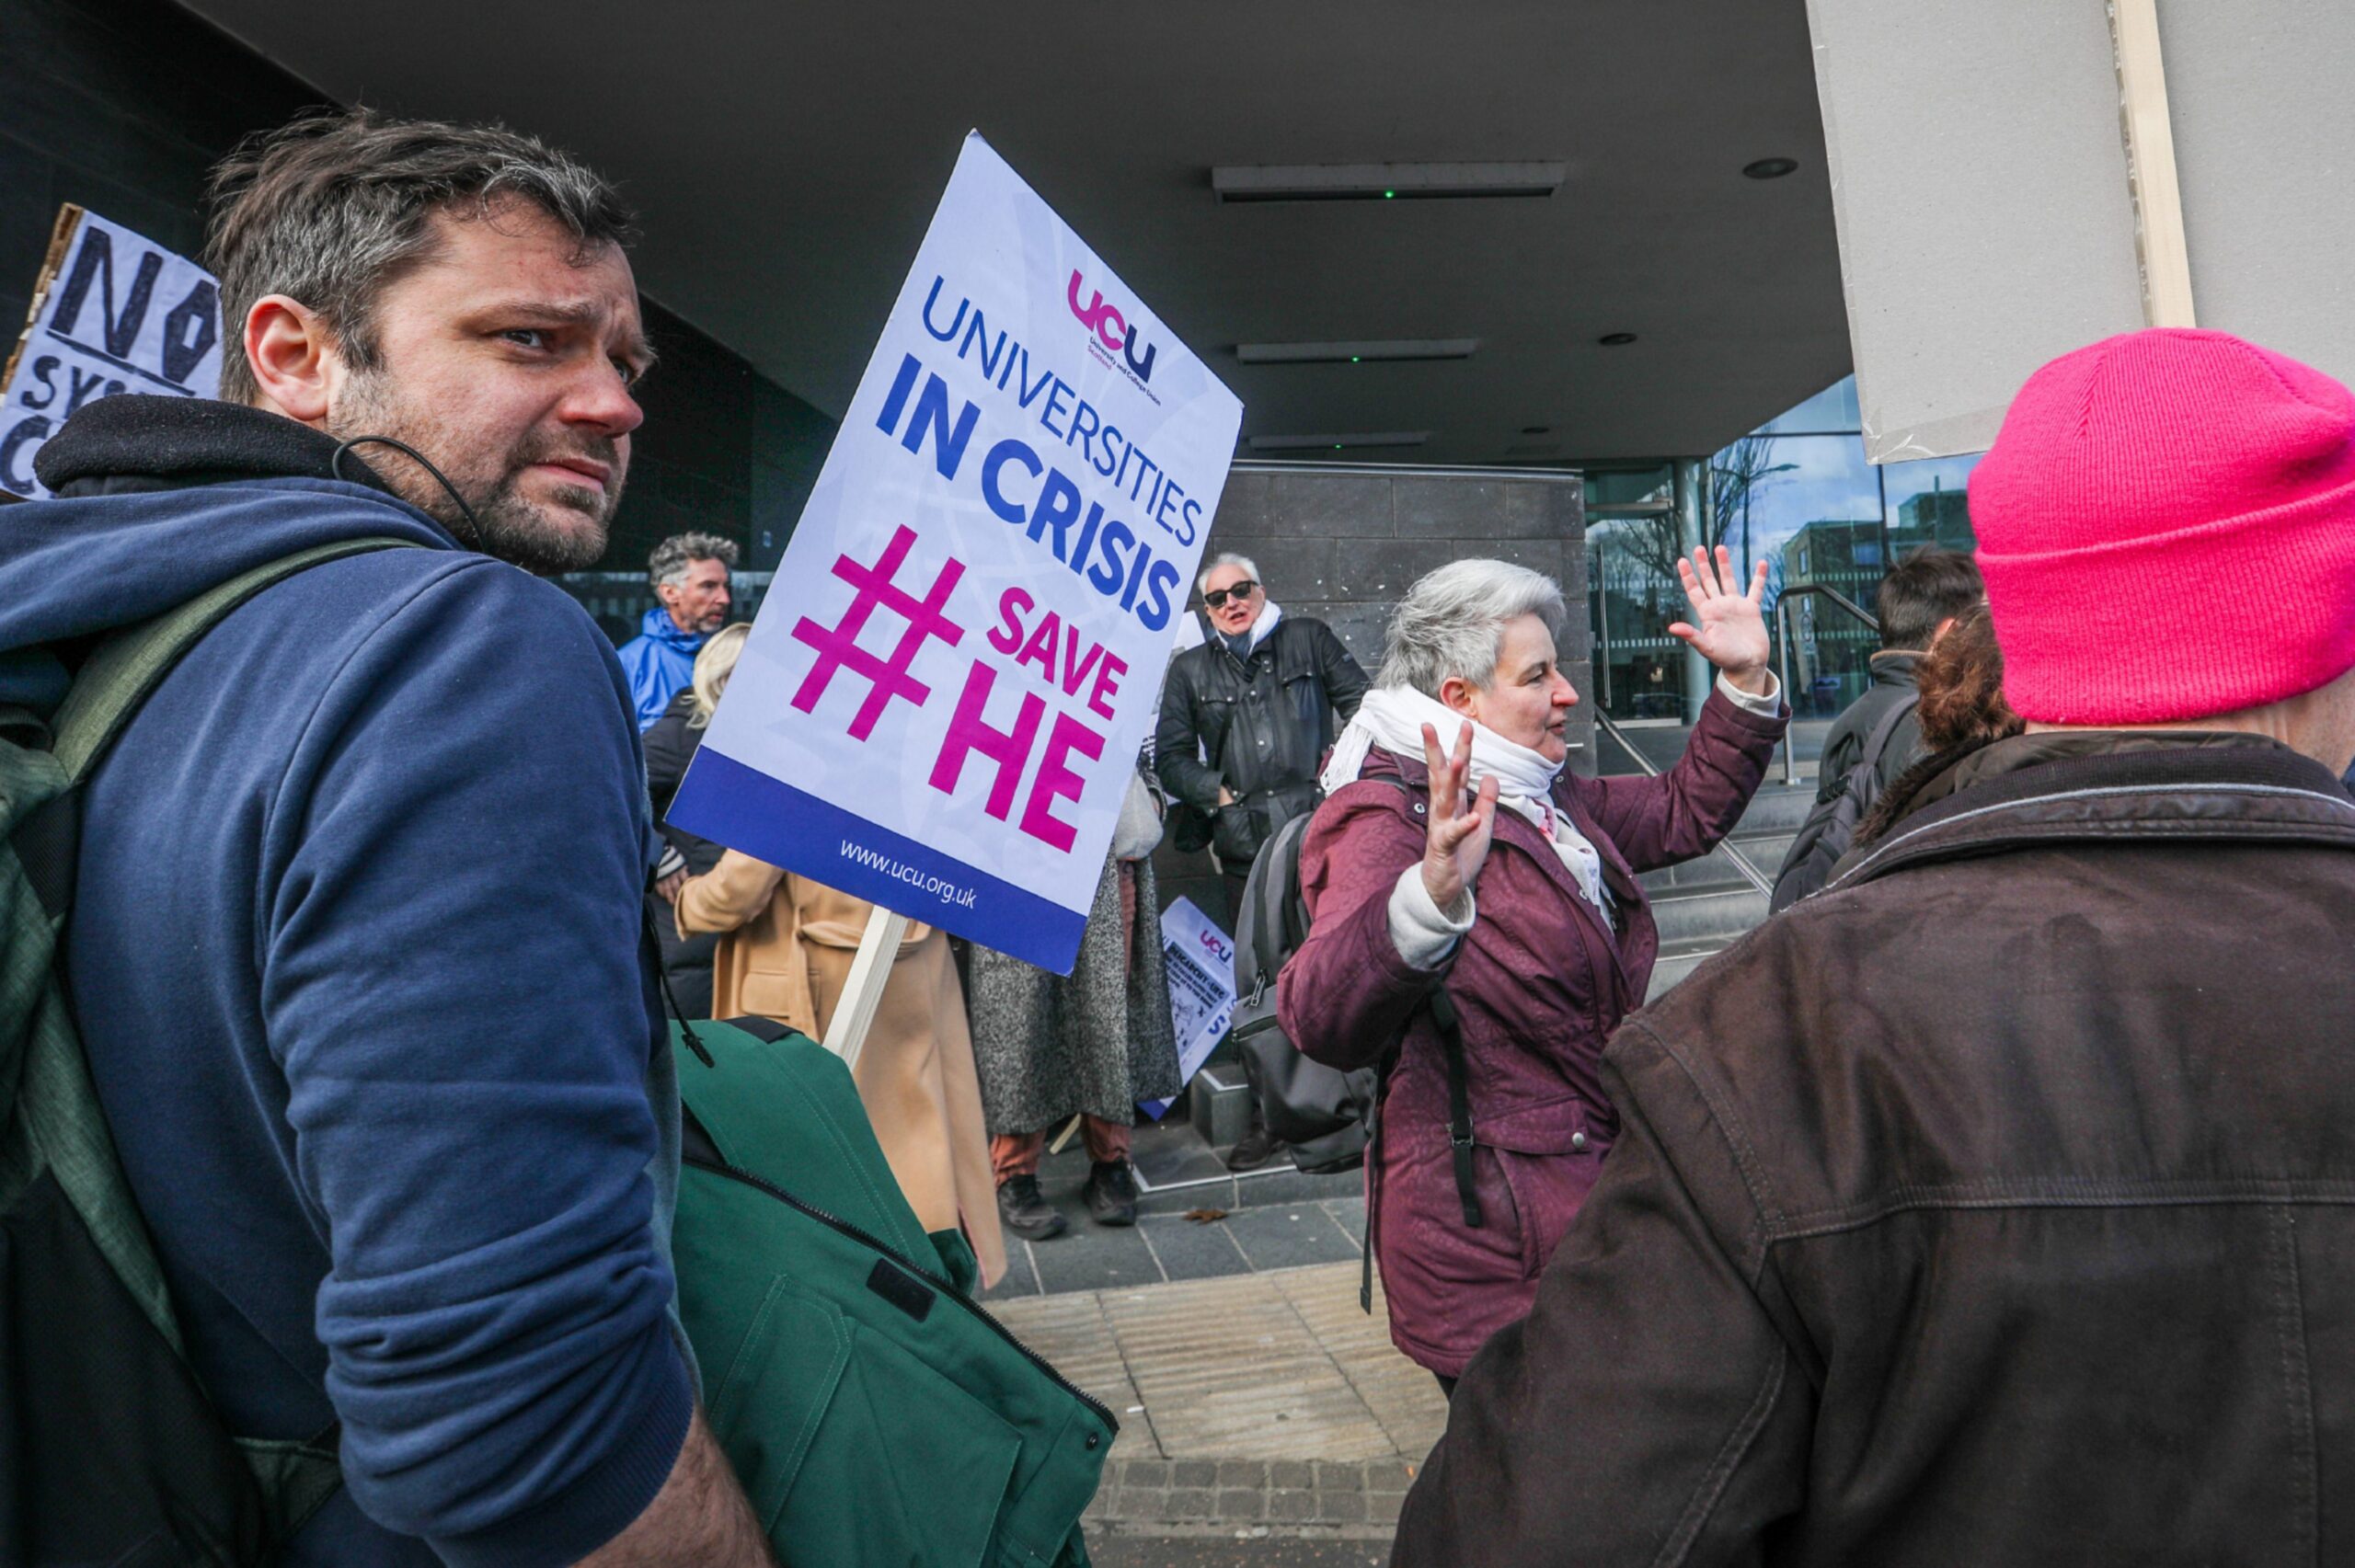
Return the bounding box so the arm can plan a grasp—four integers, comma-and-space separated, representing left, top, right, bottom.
0, 110, 768, 1568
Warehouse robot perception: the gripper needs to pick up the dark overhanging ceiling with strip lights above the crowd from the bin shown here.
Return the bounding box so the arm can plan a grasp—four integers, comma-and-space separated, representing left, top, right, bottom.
174, 0, 1849, 464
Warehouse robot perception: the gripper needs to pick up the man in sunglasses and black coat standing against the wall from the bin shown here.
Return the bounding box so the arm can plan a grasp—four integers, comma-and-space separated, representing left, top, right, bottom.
1154, 555, 1371, 1170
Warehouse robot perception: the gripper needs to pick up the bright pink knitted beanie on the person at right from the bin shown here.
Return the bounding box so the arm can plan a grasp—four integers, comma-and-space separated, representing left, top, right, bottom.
1971, 329, 2355, 725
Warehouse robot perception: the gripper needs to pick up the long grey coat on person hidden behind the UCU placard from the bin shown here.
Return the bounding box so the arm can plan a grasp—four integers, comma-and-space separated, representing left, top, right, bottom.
968, 857, 1180, 1135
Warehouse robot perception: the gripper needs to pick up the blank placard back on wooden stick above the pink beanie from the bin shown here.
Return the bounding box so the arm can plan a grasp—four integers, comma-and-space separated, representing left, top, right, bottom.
1807, 0, 2355, 464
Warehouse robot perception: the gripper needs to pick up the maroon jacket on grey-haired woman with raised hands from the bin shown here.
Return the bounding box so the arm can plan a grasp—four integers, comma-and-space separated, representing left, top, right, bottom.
1277, 692, 1785, 1378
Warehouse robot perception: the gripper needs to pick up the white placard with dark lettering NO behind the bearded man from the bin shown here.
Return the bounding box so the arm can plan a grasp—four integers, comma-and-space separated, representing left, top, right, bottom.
0, 205, 222, 497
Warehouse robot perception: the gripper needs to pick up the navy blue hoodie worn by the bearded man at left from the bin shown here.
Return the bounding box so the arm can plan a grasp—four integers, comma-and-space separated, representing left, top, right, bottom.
0, 398, 693, 1568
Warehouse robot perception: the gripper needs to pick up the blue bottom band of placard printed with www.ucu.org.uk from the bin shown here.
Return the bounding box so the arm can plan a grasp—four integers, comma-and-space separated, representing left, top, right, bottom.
666, 747, 1088, 975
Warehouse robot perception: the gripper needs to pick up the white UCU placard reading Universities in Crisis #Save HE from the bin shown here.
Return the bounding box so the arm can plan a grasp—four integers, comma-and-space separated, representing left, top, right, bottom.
669, 134, 1244, 975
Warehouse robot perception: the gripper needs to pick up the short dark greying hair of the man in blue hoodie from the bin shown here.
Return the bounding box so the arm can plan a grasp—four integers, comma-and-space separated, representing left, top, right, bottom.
205, 109, 636, 403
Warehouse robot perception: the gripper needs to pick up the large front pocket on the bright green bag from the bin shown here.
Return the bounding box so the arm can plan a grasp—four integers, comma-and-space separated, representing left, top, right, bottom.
711, 1276, 1022, 1568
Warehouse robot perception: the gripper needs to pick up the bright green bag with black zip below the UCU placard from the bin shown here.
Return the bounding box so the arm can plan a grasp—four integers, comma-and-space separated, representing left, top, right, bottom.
672, 1020, 1119, 1568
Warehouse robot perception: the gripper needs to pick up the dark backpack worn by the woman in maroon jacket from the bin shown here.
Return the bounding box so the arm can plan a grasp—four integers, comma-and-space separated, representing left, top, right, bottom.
1229, 774, 1481, 1311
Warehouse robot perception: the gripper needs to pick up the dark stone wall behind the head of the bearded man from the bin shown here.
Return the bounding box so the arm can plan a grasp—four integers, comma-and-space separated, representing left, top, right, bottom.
0, 0, 833, 635
